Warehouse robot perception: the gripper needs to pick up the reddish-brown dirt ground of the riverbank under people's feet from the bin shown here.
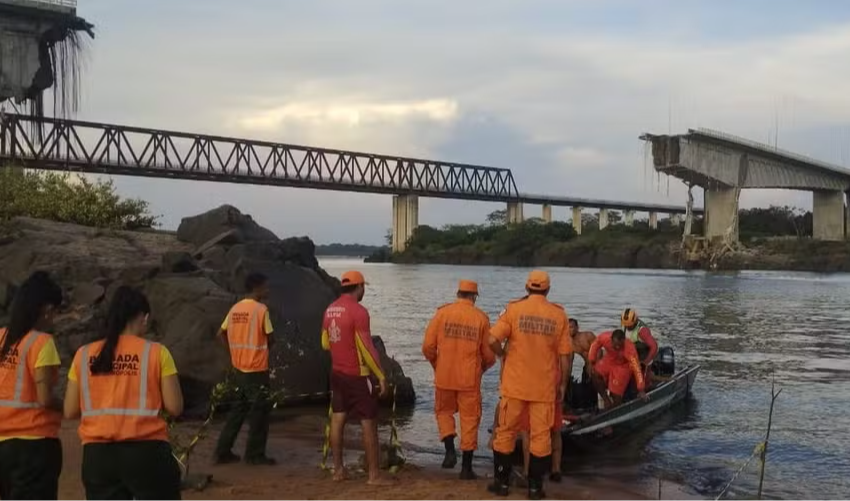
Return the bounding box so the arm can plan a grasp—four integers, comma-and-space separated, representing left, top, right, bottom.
59, 416, 696, 501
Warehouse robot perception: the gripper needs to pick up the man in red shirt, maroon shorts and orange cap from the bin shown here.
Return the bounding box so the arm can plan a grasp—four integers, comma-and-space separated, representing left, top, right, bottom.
322, 271, 393, 486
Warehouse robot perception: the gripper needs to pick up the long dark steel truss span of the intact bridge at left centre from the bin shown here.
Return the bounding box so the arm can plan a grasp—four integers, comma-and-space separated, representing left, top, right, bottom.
0, 114, 518, 201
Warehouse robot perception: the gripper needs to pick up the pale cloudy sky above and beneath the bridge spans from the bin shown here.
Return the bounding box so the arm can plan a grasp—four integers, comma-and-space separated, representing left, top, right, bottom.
43, 0, 850, 244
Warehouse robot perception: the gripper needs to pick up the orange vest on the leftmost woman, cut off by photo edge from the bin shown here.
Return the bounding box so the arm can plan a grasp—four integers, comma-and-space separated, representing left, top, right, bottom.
0, 329, 62, 438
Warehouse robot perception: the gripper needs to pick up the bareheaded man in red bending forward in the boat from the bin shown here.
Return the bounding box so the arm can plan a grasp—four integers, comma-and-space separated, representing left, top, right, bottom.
588, 329, 646, 409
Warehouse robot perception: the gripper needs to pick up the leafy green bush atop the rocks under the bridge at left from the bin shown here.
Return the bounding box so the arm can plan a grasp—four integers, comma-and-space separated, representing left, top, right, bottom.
0, 168, 158, 230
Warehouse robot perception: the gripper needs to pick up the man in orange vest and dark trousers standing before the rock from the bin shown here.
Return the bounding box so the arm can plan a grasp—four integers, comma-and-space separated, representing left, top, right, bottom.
214, 273, 276, 465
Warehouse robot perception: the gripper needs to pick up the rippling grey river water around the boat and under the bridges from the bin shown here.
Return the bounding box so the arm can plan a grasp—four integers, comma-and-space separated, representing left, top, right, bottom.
321, 259, 850, 500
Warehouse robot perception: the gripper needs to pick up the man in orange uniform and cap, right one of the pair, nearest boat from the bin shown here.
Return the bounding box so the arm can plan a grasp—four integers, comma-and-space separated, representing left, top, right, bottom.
489, 270, 572, 499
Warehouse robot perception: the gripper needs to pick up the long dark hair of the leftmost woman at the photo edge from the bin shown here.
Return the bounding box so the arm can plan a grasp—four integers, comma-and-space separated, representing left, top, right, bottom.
0, 271, 62, 359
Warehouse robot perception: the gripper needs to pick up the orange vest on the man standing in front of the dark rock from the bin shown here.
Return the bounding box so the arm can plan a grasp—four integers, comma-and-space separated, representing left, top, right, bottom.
227, 300, 269, 372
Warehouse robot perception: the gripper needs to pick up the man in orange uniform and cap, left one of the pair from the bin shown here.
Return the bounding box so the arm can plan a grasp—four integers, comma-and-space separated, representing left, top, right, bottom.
422, 280, 496, 480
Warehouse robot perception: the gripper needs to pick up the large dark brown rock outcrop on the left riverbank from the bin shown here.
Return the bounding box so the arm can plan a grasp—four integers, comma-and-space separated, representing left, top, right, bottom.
0, 205, 415, 414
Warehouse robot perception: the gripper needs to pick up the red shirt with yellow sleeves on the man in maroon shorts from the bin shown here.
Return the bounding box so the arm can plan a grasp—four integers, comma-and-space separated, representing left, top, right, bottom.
322, 294, 384, 379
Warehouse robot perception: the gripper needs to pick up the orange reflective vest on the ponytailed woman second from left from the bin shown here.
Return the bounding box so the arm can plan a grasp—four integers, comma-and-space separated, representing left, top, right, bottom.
74, 335, 168, 444
